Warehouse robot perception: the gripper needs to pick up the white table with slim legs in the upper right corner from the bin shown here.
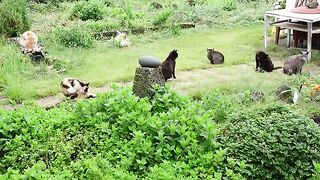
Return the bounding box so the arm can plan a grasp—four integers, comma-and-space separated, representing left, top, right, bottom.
264, 9, 320, 60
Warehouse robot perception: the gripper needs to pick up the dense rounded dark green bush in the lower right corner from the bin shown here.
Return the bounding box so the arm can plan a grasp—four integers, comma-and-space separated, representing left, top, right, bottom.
221, 104, 320, 179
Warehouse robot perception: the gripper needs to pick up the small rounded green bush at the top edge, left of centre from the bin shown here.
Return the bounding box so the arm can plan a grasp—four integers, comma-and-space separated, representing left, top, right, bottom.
71, 1, 104, 21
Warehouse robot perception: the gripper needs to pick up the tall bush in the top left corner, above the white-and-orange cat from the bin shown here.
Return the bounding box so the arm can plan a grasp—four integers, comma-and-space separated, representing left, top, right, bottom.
0, 0, 31, 37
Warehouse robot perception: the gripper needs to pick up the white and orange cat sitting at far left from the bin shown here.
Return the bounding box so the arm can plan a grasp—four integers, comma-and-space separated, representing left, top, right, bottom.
18, 31, 41, 54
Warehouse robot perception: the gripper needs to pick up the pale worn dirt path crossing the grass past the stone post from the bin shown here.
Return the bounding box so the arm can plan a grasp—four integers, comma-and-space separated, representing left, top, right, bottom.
0, 61, 320, 110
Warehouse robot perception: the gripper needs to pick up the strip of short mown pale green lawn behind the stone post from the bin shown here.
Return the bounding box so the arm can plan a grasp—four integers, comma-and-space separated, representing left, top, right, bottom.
1, 26, 318, 101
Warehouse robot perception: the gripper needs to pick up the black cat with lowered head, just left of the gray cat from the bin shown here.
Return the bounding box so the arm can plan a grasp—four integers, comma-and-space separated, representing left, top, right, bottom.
256, 51, 282, 72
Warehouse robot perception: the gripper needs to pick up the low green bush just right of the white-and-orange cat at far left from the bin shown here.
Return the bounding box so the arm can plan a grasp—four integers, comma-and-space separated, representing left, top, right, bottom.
56, 27, 95, 48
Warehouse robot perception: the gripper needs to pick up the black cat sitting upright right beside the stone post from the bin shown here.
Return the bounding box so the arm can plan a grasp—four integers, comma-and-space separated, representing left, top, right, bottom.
161, 49, 178, 81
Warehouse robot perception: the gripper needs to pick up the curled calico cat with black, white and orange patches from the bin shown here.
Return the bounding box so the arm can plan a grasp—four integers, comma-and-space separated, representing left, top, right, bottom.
60, 78, 96, 99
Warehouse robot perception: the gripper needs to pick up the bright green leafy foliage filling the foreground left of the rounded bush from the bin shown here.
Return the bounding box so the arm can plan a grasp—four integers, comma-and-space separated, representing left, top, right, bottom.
0, 88, 246, 179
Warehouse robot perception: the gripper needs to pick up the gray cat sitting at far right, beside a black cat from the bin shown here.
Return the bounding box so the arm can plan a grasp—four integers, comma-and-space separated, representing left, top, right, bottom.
283, 52, 309, 75
